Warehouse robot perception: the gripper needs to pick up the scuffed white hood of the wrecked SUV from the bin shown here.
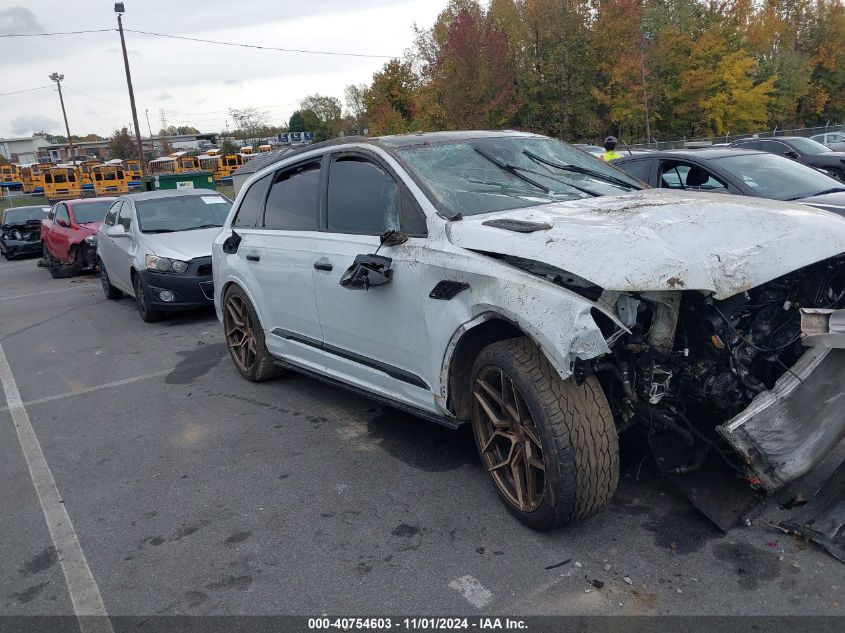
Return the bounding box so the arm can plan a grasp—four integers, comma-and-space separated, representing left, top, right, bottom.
447, 189, 845, 299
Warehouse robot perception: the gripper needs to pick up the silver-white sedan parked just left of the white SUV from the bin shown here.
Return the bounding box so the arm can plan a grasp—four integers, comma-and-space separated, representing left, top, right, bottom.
97, 189, 231, 323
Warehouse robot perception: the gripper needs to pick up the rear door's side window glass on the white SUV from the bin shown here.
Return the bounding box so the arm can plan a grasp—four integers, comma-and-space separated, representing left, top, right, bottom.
264, 160, 320, 231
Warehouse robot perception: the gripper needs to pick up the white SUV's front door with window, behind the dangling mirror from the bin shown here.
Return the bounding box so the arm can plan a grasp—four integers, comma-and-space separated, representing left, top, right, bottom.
312, 151, 442, 410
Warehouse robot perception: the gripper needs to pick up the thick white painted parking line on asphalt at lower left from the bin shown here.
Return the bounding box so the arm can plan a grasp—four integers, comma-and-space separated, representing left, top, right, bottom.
0, 345, 114, 633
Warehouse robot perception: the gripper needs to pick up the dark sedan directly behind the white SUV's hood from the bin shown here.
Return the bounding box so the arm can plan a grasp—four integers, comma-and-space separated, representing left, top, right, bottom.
613, 147, 845, 216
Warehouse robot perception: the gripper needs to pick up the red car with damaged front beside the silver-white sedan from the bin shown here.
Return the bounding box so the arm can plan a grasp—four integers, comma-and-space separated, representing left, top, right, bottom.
41, 198, 115, 278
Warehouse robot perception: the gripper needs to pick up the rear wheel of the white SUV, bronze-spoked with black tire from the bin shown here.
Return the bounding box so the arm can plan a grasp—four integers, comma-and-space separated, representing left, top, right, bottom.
223, 285, 284, 382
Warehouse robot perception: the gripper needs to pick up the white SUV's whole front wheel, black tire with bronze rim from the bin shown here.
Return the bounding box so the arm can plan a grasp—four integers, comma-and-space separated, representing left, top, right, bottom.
472, 337, 619, 530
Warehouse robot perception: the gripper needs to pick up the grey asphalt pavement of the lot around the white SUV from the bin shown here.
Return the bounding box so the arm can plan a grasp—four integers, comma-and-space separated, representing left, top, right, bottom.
0, 260, 845, 616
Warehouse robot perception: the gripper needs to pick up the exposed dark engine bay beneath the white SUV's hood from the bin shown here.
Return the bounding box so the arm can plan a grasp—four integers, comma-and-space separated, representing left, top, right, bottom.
502, 256, 845, 492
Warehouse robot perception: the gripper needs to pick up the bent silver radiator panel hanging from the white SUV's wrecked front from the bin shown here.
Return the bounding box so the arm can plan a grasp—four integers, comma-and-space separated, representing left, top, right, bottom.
716, 347, 845, 493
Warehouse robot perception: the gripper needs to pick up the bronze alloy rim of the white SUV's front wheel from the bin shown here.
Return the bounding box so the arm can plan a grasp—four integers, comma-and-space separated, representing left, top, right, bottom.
472, 366, 546, 512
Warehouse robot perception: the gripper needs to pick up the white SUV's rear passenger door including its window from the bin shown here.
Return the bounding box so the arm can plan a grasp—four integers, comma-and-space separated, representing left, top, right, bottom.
237, 156, 323, 371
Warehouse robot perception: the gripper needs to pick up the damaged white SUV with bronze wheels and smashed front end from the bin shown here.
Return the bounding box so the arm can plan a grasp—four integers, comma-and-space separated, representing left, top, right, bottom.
213, 132, 845, 529
